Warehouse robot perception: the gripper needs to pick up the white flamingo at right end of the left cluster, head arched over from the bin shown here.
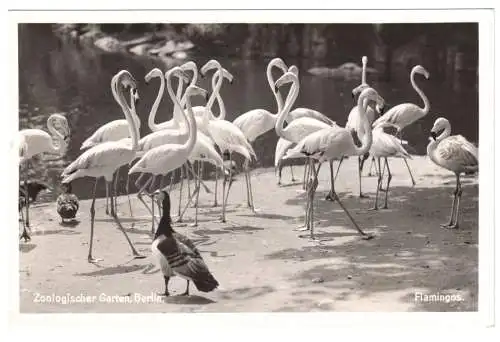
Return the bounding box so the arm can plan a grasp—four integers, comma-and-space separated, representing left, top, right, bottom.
196, 59, 257, 222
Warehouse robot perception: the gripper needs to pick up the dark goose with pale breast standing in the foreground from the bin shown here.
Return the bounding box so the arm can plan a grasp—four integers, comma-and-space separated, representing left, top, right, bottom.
151, 191, 219, 296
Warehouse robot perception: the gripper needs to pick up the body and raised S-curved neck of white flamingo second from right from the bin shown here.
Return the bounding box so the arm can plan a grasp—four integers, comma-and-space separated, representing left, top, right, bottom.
372, 65, 430, 138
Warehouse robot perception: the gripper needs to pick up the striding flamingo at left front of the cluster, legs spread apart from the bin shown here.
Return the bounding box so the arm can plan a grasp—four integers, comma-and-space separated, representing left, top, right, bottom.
62, 70, 145, 263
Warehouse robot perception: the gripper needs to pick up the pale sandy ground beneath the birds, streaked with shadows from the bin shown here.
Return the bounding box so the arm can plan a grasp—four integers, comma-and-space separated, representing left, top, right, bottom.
19, 157, 478, 313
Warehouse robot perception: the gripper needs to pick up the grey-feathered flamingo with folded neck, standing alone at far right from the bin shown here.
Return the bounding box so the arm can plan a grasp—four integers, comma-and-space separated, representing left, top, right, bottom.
427, 117, 479, 229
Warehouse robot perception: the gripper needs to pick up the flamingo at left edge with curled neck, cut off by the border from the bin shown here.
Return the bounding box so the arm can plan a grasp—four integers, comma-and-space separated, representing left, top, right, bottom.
17, 113, 70, 242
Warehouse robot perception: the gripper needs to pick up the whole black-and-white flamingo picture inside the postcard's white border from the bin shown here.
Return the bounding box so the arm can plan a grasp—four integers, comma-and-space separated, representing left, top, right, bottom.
4, 5, 494, 330
